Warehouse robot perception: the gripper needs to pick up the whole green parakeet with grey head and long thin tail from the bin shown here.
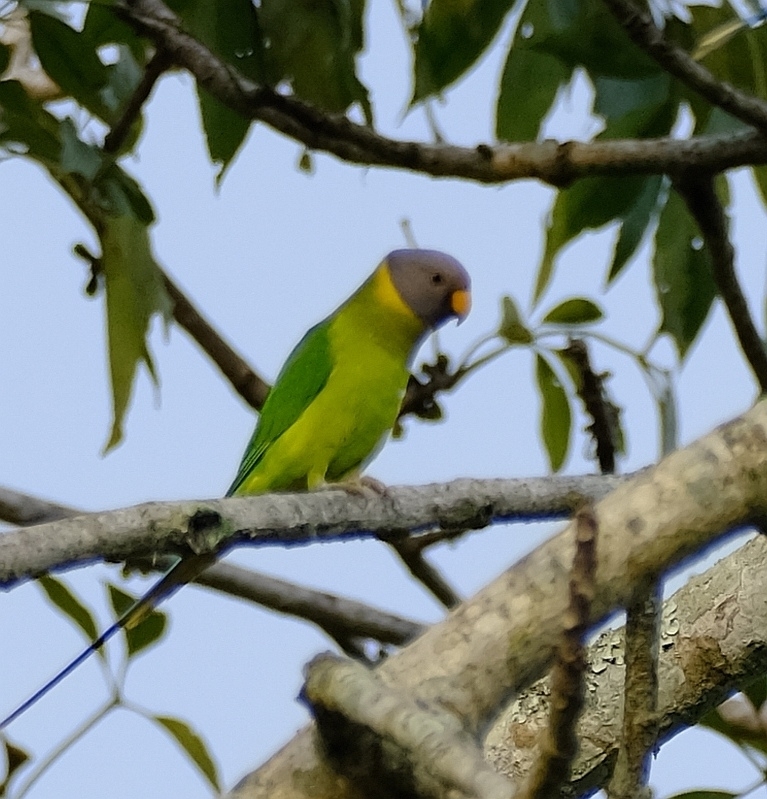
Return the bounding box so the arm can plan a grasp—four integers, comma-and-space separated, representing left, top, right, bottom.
0, 250, 471, 729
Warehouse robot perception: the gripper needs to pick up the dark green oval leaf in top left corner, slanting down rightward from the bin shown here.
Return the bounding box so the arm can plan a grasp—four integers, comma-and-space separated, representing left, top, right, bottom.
29, 11, 114, 122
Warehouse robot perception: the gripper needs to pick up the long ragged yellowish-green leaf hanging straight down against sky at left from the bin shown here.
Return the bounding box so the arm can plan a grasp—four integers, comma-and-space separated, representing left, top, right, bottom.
100, 203, 170, 451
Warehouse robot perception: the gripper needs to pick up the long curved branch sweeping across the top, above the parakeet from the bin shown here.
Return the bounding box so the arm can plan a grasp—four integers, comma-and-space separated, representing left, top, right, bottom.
111, 0, 767, 186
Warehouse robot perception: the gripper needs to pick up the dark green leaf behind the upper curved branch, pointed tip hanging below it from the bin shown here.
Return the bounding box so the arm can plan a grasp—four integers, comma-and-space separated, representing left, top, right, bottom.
183, 0, 267, 182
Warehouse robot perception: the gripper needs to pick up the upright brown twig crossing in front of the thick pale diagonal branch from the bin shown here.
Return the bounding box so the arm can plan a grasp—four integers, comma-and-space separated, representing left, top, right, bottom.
520, 505, 599, 799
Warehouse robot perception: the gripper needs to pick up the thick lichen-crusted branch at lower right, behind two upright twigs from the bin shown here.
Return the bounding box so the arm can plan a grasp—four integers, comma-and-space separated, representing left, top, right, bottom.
488, 536, 767, 796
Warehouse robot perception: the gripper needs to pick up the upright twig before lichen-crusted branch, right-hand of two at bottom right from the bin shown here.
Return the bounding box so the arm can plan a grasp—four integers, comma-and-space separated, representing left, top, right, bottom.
607, 580, 663, 799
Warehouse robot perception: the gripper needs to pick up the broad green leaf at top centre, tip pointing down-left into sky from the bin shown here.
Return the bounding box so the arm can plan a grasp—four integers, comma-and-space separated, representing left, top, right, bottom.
412, 0, 514, 103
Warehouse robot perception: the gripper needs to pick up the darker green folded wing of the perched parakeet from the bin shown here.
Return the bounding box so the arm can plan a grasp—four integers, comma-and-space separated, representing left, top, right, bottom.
226, 318, 333, 497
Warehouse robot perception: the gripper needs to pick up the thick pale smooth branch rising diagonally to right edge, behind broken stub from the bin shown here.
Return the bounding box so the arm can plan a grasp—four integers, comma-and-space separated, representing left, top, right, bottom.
234, 401, 767, 799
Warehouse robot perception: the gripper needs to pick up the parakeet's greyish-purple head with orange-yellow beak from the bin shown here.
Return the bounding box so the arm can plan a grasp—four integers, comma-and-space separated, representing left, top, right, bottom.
385, 250, 471, 328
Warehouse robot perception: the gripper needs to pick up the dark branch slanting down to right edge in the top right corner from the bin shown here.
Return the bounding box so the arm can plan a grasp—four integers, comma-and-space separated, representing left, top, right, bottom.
604, 0, 767, 133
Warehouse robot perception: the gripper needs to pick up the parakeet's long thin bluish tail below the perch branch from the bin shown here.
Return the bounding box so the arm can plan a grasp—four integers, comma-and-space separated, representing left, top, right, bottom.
0, 553, 216, 730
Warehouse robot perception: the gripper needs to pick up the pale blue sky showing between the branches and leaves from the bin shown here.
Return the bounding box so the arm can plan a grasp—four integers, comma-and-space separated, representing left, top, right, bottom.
0, 3, 767, 799
